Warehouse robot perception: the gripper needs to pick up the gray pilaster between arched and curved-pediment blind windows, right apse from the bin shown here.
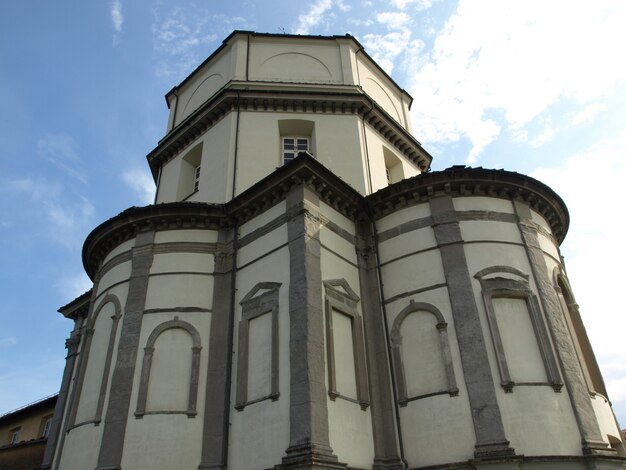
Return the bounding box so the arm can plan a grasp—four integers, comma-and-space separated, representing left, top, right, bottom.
430, 196, 515, 459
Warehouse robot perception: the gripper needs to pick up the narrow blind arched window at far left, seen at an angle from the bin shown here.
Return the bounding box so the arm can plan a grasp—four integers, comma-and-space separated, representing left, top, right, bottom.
69, 294, 122, 427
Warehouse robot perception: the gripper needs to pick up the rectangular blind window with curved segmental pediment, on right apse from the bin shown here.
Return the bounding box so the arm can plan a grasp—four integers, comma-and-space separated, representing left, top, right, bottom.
474, 266, 563, 392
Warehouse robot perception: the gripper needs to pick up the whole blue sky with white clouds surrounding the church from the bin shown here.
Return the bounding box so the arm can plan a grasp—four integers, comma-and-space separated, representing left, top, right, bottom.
0, 0, 626, 427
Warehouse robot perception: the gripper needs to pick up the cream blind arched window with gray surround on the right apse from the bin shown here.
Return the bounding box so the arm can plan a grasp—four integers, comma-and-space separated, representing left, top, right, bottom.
391, 301, 459, 406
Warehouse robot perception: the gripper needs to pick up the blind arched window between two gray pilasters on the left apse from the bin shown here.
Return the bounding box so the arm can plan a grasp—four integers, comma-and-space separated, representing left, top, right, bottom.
135, 317, 202, 418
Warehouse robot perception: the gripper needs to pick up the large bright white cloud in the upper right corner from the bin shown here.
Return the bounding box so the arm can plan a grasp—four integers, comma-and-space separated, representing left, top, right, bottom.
408, 0, 626, 161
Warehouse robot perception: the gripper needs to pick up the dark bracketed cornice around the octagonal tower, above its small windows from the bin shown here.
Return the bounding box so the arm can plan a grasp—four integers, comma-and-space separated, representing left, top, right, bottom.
146, 82, 432, 181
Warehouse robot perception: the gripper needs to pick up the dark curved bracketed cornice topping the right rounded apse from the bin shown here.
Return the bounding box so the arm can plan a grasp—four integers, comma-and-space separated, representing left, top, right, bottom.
366, 165, 569, 243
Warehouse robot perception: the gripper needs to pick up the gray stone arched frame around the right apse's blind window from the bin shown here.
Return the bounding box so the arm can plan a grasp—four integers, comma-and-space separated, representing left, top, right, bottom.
390, 300, 459, 406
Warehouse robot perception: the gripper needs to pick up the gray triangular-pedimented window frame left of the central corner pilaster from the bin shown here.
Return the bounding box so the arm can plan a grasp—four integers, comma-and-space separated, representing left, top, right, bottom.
235, 282, 281, 411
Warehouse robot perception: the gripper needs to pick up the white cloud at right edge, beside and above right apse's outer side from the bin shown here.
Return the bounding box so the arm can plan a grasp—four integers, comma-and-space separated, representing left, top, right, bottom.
532, 131, 626, 408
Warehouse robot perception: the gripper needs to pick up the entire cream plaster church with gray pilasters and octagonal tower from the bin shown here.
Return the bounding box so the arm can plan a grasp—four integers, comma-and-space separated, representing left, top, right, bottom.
43, 32, 626, 470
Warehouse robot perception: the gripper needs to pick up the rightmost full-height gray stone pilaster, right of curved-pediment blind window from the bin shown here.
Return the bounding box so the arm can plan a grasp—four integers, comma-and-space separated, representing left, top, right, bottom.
513, 201, 615, 455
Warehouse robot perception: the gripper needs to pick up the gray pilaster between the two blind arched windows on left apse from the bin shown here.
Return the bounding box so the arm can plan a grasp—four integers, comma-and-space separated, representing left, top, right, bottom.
97, 231, 154, 470
